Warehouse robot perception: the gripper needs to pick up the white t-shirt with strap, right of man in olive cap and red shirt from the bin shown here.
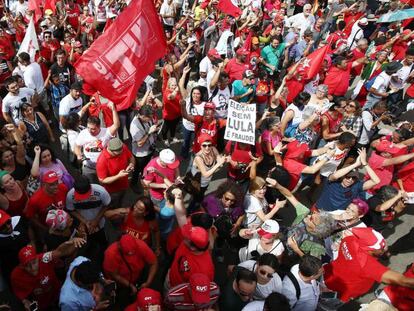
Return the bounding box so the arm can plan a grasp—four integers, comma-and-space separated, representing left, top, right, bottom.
129, 116, 157, 157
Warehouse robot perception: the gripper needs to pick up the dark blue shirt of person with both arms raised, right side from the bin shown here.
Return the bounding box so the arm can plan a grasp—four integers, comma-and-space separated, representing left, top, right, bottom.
316, 179, 365, 212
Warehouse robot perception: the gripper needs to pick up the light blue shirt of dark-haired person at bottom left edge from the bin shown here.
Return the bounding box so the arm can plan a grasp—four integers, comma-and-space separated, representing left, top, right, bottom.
59, 256, 96, 311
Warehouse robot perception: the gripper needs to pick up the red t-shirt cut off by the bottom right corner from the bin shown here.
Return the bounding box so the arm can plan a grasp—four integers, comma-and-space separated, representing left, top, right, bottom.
384, 265, 414, 311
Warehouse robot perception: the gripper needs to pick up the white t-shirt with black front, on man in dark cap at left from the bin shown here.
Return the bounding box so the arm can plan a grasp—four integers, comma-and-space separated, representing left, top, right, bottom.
66, 184, 111, 229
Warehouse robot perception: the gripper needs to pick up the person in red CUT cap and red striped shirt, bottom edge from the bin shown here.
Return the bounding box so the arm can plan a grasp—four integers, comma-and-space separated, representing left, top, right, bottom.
165, 273, 220, 311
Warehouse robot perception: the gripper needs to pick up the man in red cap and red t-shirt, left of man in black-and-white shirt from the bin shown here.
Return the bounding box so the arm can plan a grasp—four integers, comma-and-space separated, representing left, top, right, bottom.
25, 171, 68, 232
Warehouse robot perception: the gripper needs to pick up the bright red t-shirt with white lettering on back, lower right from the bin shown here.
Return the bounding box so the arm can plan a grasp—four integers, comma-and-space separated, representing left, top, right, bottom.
324, 236, 389, 302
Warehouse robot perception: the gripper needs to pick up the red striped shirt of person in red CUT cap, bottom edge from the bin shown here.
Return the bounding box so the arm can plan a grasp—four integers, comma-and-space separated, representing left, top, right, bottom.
165, 282, 220, 311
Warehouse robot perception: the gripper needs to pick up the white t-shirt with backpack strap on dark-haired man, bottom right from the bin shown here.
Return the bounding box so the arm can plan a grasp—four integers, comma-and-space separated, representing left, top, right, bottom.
282, 264, 320, 311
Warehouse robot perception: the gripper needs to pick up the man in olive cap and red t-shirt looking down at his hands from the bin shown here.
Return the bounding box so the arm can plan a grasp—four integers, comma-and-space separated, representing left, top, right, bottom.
96, 137, 135, 207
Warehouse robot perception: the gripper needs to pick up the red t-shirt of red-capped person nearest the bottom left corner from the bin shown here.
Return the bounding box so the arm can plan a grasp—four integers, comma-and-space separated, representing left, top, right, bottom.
11, 252, 61, 310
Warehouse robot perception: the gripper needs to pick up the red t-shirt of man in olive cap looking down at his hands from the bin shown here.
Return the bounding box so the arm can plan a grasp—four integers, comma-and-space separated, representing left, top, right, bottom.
96, 144, 132, 193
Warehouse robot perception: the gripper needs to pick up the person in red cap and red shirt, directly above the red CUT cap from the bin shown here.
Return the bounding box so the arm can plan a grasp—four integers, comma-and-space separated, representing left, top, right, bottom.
167, 224, 214, 288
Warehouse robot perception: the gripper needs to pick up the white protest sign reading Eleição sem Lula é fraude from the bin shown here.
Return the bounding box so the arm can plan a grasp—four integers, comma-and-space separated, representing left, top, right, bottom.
224, 99, 256, 145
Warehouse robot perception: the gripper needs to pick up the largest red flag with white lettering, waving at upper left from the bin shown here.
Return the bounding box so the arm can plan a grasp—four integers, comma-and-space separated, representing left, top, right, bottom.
75, 0, 167, 110
